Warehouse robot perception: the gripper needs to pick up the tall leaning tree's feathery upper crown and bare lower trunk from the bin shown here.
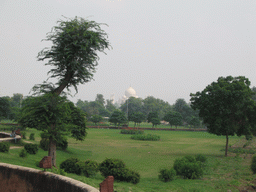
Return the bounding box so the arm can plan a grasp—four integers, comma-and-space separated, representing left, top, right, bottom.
26, 17, 110, 166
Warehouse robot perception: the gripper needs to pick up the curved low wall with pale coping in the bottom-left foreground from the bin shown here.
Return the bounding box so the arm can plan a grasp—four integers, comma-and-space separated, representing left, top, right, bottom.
0, 163, 99, 192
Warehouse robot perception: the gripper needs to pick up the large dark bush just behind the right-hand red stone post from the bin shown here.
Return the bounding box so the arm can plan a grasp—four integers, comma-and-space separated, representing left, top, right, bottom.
99, 159, 140, 184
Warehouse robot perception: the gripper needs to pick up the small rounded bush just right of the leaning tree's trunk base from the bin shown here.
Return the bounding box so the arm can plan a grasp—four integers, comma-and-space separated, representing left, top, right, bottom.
60, 157, 81, 175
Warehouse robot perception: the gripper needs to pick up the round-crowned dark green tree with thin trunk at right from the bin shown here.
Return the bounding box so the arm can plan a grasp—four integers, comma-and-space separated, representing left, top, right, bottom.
190, 76, 256, 156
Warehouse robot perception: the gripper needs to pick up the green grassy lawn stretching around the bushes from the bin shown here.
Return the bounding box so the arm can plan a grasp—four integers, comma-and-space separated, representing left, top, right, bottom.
0, 129, 256, 192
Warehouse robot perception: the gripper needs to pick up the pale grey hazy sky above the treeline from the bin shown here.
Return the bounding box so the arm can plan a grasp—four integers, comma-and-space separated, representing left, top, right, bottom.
0, 0, 256, 104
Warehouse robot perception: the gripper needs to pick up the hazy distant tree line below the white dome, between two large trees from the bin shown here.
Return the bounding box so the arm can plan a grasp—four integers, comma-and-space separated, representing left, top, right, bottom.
76, 94, 200, 126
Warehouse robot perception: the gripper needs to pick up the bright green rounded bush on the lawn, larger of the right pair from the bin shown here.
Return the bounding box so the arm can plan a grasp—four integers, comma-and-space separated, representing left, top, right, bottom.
173, 156, 203, 179
